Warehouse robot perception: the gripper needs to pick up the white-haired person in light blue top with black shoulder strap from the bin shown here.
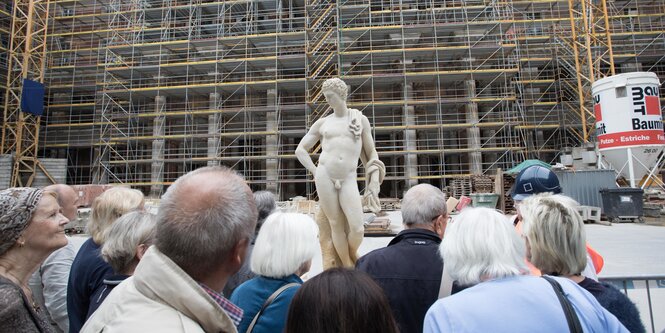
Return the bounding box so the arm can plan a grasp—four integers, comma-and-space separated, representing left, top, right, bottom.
423, 208, 628, 333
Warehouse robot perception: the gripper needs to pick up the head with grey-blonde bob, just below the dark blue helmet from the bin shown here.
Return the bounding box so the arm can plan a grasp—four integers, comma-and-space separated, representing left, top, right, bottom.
520, 194, 587, 276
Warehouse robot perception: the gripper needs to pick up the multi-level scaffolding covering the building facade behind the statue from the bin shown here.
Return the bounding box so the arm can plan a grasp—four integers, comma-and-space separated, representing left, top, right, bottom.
37, 0, 665, 199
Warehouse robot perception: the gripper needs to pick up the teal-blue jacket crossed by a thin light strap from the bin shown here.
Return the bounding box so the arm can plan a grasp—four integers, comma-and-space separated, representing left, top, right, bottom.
230, 274, 302, 333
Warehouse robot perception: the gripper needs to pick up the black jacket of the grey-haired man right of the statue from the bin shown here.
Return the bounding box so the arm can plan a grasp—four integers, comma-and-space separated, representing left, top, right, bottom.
356, 229, 458, 333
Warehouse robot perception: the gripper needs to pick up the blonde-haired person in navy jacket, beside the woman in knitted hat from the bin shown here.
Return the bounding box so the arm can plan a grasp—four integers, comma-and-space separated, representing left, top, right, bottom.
67, 187, 145, 333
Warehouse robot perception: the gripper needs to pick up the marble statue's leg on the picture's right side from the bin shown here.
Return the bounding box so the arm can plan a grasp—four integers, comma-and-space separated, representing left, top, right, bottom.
339, 175, 365, 265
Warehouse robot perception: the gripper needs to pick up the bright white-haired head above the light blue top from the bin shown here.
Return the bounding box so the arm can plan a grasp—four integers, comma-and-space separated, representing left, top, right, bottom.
440, 207, 528, 285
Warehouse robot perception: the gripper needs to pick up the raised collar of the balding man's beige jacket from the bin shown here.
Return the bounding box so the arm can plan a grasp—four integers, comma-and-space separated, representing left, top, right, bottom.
133, 246, 236, 332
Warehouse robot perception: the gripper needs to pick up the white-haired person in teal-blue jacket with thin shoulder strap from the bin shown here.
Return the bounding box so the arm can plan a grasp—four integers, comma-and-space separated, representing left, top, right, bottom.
231, 213, 319, 333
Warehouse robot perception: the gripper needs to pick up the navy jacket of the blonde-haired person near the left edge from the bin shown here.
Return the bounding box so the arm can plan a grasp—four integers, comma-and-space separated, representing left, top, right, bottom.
67, 238, 113, 333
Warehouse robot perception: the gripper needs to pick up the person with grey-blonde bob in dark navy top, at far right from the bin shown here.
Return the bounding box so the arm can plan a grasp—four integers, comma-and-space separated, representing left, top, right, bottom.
520, 194, 645, 333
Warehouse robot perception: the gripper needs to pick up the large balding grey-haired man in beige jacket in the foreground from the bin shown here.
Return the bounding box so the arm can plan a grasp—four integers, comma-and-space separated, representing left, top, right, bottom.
82, 167, 257, 333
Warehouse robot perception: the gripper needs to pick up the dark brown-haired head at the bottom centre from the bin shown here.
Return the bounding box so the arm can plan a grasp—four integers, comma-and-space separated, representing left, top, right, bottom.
284, 268, 398, 333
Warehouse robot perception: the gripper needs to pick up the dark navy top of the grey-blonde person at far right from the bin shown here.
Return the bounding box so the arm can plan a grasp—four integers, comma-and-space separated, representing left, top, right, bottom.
578, 278, 646, 333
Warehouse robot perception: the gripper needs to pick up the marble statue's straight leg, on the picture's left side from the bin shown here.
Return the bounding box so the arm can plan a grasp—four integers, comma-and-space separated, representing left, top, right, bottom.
314, 166, 354, 267
